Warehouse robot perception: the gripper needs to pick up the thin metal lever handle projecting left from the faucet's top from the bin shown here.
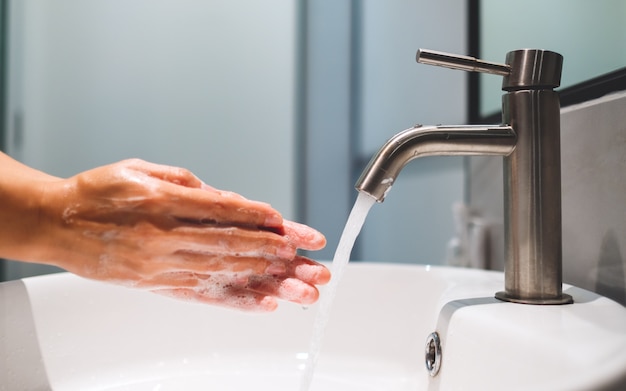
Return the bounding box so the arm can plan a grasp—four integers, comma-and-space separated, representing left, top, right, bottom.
416, 49, 511, 76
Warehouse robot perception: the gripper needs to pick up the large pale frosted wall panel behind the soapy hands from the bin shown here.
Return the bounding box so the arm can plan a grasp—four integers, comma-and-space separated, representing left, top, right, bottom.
1, 0, 297, 278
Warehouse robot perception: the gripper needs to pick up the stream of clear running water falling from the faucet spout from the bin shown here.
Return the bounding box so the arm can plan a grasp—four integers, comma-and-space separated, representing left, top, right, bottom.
300, 193, 376, 391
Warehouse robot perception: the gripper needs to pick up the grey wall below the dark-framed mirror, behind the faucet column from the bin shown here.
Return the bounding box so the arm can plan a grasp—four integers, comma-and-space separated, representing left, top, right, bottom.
469, 92, 626, 305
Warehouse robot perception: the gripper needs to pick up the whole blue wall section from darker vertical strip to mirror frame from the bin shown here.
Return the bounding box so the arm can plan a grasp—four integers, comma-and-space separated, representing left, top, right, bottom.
298, 0, 467, 264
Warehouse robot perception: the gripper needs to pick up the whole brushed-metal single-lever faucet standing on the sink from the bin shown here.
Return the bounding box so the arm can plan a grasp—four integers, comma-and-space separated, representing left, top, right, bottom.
355, 49, 573, 304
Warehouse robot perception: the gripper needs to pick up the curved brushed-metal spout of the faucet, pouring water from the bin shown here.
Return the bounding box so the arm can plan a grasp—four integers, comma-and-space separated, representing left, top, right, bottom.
355, 125, 517, 202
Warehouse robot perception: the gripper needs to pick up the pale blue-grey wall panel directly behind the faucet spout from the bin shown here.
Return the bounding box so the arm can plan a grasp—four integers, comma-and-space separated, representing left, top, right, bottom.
355, 0, 467, 264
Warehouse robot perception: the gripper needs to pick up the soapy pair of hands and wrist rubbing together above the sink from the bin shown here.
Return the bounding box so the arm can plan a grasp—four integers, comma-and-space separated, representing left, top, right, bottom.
0, 153, 330, 311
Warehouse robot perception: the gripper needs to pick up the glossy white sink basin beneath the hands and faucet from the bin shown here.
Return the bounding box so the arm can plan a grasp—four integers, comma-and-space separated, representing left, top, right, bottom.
0, 263, 626, 391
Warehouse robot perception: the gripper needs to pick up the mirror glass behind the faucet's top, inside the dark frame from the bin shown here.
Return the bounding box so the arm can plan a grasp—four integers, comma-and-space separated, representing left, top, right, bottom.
477, 0, 626, 118
